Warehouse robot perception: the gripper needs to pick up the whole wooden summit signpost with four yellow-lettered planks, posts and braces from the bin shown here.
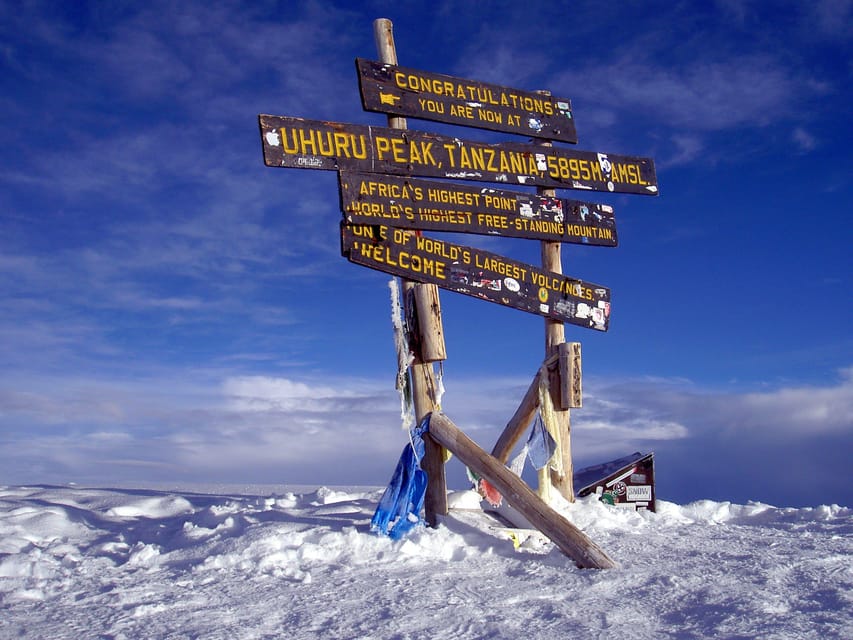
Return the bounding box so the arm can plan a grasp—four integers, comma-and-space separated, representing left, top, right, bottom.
258, 19, 658, 568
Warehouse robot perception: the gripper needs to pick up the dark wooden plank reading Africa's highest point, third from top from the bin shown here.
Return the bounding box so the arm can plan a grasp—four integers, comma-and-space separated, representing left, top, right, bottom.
338, 171, 618, 247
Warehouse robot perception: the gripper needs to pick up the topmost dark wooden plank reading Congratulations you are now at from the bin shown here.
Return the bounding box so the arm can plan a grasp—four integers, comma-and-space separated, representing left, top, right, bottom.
355, 58, 578, 143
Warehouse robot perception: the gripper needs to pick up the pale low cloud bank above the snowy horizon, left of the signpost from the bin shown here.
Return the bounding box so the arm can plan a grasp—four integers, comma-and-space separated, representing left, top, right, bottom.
0, 374, 406, 483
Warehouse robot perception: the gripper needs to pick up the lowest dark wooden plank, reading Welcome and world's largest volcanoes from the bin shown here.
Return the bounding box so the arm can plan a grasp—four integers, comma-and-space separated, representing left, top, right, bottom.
341, 224, 610, 331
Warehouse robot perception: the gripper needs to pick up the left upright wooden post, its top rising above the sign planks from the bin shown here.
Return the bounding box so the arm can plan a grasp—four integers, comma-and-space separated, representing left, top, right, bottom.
373, 18, 447, 527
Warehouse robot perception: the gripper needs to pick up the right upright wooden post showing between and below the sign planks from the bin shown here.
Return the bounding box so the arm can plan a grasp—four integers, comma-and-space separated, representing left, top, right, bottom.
536, 101, 575, 502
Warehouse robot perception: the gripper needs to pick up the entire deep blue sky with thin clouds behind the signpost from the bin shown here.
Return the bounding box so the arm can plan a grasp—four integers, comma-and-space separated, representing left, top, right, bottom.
0, 0, 853, 506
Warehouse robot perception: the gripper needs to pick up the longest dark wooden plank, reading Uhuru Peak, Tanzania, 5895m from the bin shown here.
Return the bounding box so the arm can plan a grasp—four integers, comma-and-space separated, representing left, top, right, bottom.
258, 115, 658, 195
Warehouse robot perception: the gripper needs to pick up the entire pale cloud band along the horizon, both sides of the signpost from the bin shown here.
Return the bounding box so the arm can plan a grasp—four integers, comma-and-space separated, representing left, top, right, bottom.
0, 369, 853, 499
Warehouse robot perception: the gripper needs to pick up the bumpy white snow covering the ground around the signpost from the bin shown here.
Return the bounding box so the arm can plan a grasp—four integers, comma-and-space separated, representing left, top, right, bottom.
0, 486, 853, 640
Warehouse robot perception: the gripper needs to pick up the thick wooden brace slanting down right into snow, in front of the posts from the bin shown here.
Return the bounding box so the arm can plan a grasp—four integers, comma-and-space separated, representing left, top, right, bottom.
429, 413, 616, 569
